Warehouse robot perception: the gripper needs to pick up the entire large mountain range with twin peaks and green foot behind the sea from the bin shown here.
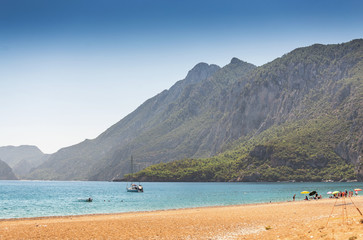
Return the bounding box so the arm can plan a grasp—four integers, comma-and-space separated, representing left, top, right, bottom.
29, 40, 363, 181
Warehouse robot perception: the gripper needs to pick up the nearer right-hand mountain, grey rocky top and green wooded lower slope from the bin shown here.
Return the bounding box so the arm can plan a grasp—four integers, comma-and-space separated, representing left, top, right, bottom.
132, 39, 363, 181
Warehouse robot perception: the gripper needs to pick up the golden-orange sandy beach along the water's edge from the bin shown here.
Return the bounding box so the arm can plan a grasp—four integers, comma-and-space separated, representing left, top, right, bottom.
0, 197, 363, 240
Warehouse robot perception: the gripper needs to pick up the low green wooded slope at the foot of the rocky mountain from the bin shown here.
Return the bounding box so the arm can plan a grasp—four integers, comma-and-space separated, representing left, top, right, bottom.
126, 116, 356, 181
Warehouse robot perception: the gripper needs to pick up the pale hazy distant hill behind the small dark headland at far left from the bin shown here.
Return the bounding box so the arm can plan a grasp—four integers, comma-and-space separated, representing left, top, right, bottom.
0, 145, 49, 177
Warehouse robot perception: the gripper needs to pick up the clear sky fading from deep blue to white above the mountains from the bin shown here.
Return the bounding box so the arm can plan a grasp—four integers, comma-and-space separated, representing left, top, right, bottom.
0, 0, 363, 153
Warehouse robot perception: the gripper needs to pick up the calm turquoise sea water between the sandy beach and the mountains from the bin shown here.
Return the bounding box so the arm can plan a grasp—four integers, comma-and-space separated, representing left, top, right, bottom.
0, 181, 363, 219
